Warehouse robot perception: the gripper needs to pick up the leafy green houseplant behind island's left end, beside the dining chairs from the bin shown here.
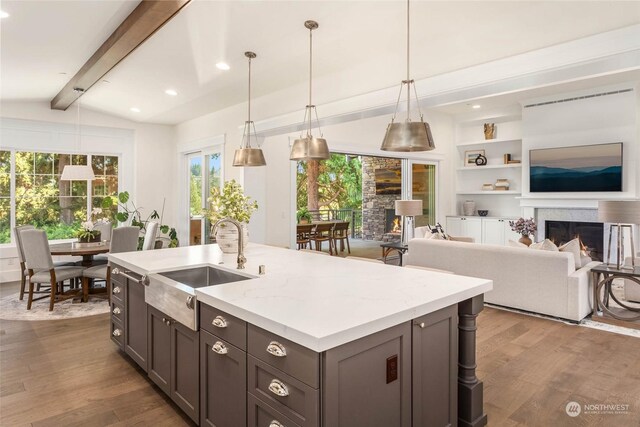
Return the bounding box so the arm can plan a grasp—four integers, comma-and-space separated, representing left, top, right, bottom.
102, 191, 180, 250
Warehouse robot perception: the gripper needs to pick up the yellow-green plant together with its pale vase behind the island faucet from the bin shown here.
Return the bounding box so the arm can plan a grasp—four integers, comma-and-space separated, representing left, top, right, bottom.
203, 179, 258, 253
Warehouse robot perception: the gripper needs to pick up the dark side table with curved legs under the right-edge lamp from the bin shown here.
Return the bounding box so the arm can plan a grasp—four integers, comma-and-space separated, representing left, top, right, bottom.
591, 264, 640, 322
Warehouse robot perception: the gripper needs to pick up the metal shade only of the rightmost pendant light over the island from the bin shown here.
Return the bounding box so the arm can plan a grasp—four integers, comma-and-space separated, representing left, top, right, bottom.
380, 121, 436, 152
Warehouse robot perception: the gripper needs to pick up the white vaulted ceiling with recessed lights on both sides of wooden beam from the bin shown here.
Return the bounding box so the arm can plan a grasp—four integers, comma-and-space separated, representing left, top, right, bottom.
0, 0, 640, 124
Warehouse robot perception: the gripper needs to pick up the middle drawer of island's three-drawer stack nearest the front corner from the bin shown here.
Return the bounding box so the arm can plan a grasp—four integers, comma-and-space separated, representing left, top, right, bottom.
248, 356, 319, 427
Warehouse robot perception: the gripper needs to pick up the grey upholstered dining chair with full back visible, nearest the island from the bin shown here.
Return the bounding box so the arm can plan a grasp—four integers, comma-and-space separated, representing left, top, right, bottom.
20, 229, 84, 311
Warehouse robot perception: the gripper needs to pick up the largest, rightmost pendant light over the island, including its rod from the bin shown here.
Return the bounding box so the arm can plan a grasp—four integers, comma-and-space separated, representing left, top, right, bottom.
380, 0, 436, 151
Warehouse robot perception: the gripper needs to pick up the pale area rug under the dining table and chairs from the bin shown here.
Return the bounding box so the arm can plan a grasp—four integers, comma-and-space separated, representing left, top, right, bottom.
0, 293, 109, 321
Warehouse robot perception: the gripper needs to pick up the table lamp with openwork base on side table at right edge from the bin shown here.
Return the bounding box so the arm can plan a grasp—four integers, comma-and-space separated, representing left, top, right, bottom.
598, 200, 640, 270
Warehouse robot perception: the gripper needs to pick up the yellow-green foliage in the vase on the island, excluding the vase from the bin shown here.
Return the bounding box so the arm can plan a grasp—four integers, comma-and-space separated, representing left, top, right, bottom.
204, 179, 258, 223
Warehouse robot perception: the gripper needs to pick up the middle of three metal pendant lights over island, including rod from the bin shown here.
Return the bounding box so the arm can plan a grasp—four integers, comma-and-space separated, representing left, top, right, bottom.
289, 21, 331, 160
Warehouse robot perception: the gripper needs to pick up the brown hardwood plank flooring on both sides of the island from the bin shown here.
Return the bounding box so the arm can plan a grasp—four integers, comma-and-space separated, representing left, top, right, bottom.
0, 285, 640, 427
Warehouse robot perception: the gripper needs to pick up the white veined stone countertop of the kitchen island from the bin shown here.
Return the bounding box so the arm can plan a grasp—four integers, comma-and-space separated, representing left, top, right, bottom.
109, 243, 493, 352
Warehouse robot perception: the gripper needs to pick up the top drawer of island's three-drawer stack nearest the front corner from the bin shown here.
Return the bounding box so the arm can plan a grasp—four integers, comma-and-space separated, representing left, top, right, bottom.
247, 325, 320, 388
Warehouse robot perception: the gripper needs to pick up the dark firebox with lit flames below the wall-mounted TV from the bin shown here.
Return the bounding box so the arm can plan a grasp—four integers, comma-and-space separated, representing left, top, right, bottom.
544, 221, 604, 261
